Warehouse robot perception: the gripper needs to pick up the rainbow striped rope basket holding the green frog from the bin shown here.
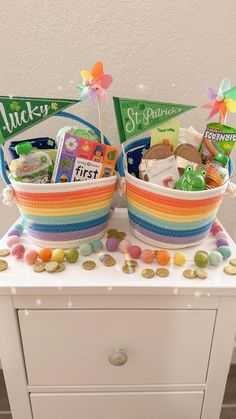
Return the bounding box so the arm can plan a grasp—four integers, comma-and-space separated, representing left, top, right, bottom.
118, 137, 232, 249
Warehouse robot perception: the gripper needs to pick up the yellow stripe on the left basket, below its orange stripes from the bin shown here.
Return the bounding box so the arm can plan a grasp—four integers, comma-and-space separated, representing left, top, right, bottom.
19, 198, 112, 217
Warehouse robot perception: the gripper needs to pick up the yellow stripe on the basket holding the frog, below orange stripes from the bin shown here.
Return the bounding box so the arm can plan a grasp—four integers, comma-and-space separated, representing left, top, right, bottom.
128, 197, 216, 222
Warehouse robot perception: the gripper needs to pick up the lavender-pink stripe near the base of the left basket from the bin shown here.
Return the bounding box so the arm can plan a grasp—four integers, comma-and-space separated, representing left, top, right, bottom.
26, 221, 108, 241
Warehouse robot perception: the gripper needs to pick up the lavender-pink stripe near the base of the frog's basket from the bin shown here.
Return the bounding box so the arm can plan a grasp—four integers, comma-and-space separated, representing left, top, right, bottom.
129, 220, 210, 245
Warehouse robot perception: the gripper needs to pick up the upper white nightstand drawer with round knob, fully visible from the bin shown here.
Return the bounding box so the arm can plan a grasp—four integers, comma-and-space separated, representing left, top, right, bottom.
19, 310, 215, 386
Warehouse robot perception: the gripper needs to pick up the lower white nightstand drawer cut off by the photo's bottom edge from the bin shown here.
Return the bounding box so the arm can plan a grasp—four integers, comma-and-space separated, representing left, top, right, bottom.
31, 392, 203, 419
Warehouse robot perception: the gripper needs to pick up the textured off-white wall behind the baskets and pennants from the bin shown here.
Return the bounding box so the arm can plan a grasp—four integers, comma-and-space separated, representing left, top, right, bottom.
0, 0, 236, 241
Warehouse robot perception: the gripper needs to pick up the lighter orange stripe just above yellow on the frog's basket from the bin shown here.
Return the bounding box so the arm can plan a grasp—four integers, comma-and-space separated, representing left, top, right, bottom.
127, 191, 219, 217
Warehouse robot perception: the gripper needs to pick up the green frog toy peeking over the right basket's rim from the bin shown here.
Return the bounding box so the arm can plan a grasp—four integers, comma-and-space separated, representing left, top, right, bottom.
176, 165, 206, 191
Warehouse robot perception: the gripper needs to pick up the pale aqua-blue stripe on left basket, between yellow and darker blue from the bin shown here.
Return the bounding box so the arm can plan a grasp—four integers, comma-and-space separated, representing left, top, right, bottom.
22, 205, 110, 225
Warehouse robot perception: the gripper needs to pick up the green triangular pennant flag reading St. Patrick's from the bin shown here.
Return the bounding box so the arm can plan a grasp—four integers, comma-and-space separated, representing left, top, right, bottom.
113, 97, 196, 143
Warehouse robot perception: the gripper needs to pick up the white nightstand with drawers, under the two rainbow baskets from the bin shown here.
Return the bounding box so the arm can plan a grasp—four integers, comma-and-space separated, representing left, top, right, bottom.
0, 210, 236, 419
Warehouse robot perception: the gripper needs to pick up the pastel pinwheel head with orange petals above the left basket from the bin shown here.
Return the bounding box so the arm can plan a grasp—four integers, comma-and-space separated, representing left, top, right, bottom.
78, 61, 112, 103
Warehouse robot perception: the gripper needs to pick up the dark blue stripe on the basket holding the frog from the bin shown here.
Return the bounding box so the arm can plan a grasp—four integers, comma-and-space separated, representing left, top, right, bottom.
128, 210, 212, 237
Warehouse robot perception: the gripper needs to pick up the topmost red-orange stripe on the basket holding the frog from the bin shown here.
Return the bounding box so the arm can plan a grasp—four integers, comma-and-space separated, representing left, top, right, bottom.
126, 182, 223, 208
